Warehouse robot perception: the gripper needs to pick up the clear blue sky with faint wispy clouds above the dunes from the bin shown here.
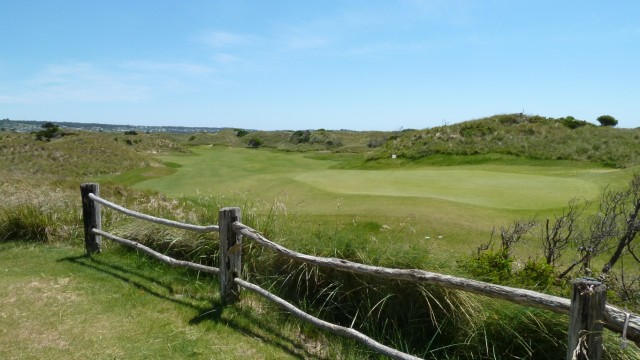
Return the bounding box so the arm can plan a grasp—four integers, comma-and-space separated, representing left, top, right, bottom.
0, 0, 640, 130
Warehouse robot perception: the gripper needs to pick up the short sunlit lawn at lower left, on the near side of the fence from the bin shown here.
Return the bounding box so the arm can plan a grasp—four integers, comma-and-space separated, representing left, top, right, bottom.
0, 243, 338, 359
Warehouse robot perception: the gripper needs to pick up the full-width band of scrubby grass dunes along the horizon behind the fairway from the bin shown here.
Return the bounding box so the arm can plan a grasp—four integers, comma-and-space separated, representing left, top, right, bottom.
5, 114, 640, 169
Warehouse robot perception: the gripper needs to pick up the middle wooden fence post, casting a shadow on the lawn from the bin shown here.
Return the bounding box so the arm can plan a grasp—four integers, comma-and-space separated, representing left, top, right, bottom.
218, 207, 242, 304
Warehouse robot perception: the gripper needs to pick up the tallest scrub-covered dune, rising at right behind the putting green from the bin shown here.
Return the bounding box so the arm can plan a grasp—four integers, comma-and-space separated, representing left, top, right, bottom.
370, 114, 640, 167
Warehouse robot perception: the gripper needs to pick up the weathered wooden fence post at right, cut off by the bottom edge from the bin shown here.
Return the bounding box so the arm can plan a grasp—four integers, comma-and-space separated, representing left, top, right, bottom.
567, 278, 607, 360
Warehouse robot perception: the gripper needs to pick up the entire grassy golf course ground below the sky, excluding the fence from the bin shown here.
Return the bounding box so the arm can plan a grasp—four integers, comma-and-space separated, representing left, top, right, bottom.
0, 115, 640, 359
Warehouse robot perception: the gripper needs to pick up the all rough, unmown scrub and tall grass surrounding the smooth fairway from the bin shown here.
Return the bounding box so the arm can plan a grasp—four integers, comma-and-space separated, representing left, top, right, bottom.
0, 115, 640, 359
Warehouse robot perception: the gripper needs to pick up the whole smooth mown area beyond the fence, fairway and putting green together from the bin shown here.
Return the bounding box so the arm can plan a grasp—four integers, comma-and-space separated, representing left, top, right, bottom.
125, 146, 632, 257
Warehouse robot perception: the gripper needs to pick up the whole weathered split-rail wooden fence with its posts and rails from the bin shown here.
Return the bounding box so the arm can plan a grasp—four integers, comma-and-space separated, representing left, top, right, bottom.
80, 184, 640, 360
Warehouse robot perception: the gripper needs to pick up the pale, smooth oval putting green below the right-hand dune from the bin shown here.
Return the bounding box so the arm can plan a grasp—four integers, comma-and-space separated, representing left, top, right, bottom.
295, 168, 600, 209
